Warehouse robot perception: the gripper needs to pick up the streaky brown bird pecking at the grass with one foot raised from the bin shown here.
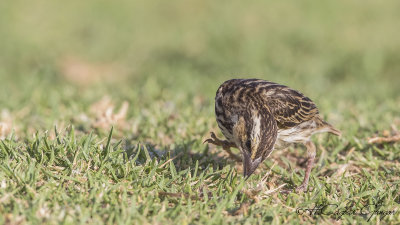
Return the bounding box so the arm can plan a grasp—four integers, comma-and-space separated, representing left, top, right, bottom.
205, 79, 341, 192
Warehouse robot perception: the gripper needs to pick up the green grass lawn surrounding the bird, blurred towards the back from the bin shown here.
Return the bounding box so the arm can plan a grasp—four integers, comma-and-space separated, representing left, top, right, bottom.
0, 0, 400, 224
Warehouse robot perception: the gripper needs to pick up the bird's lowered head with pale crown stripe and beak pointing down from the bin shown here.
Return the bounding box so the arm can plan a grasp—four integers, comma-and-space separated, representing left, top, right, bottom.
233, 113, 276, 178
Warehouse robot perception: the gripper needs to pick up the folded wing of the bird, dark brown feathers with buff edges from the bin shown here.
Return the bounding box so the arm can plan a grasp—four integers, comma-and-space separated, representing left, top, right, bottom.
265, 86, 318, 129
